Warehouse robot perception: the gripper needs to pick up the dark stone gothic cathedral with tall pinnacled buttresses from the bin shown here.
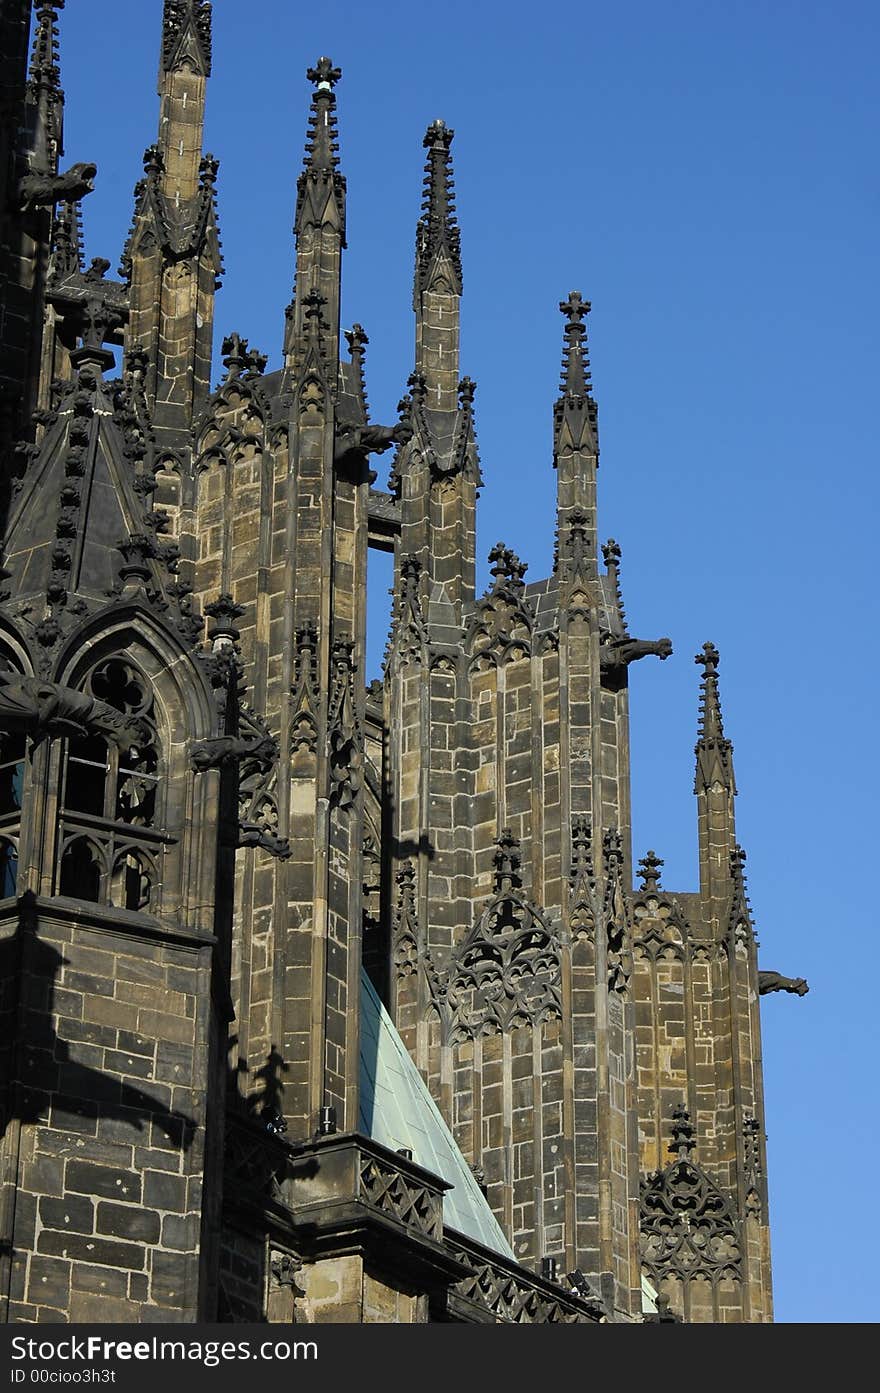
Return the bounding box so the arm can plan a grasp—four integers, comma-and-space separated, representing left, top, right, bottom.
0, 0, 806, 1323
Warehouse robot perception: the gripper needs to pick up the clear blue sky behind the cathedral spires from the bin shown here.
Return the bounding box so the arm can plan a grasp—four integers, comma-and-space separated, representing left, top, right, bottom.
53, 0, 880, 1322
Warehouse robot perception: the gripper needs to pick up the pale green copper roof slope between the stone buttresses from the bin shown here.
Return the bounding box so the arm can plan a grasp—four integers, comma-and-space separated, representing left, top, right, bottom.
359, 972, 514, 1258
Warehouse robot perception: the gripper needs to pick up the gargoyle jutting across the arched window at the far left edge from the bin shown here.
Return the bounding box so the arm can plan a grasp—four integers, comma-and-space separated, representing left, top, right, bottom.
0, 670, 145, 751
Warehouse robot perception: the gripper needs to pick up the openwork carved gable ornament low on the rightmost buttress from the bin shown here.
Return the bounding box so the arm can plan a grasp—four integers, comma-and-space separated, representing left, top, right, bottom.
639, 1107, 742, 1283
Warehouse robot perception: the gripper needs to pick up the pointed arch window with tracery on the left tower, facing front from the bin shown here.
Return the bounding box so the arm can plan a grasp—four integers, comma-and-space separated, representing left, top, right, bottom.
56, 657, 171, 912
